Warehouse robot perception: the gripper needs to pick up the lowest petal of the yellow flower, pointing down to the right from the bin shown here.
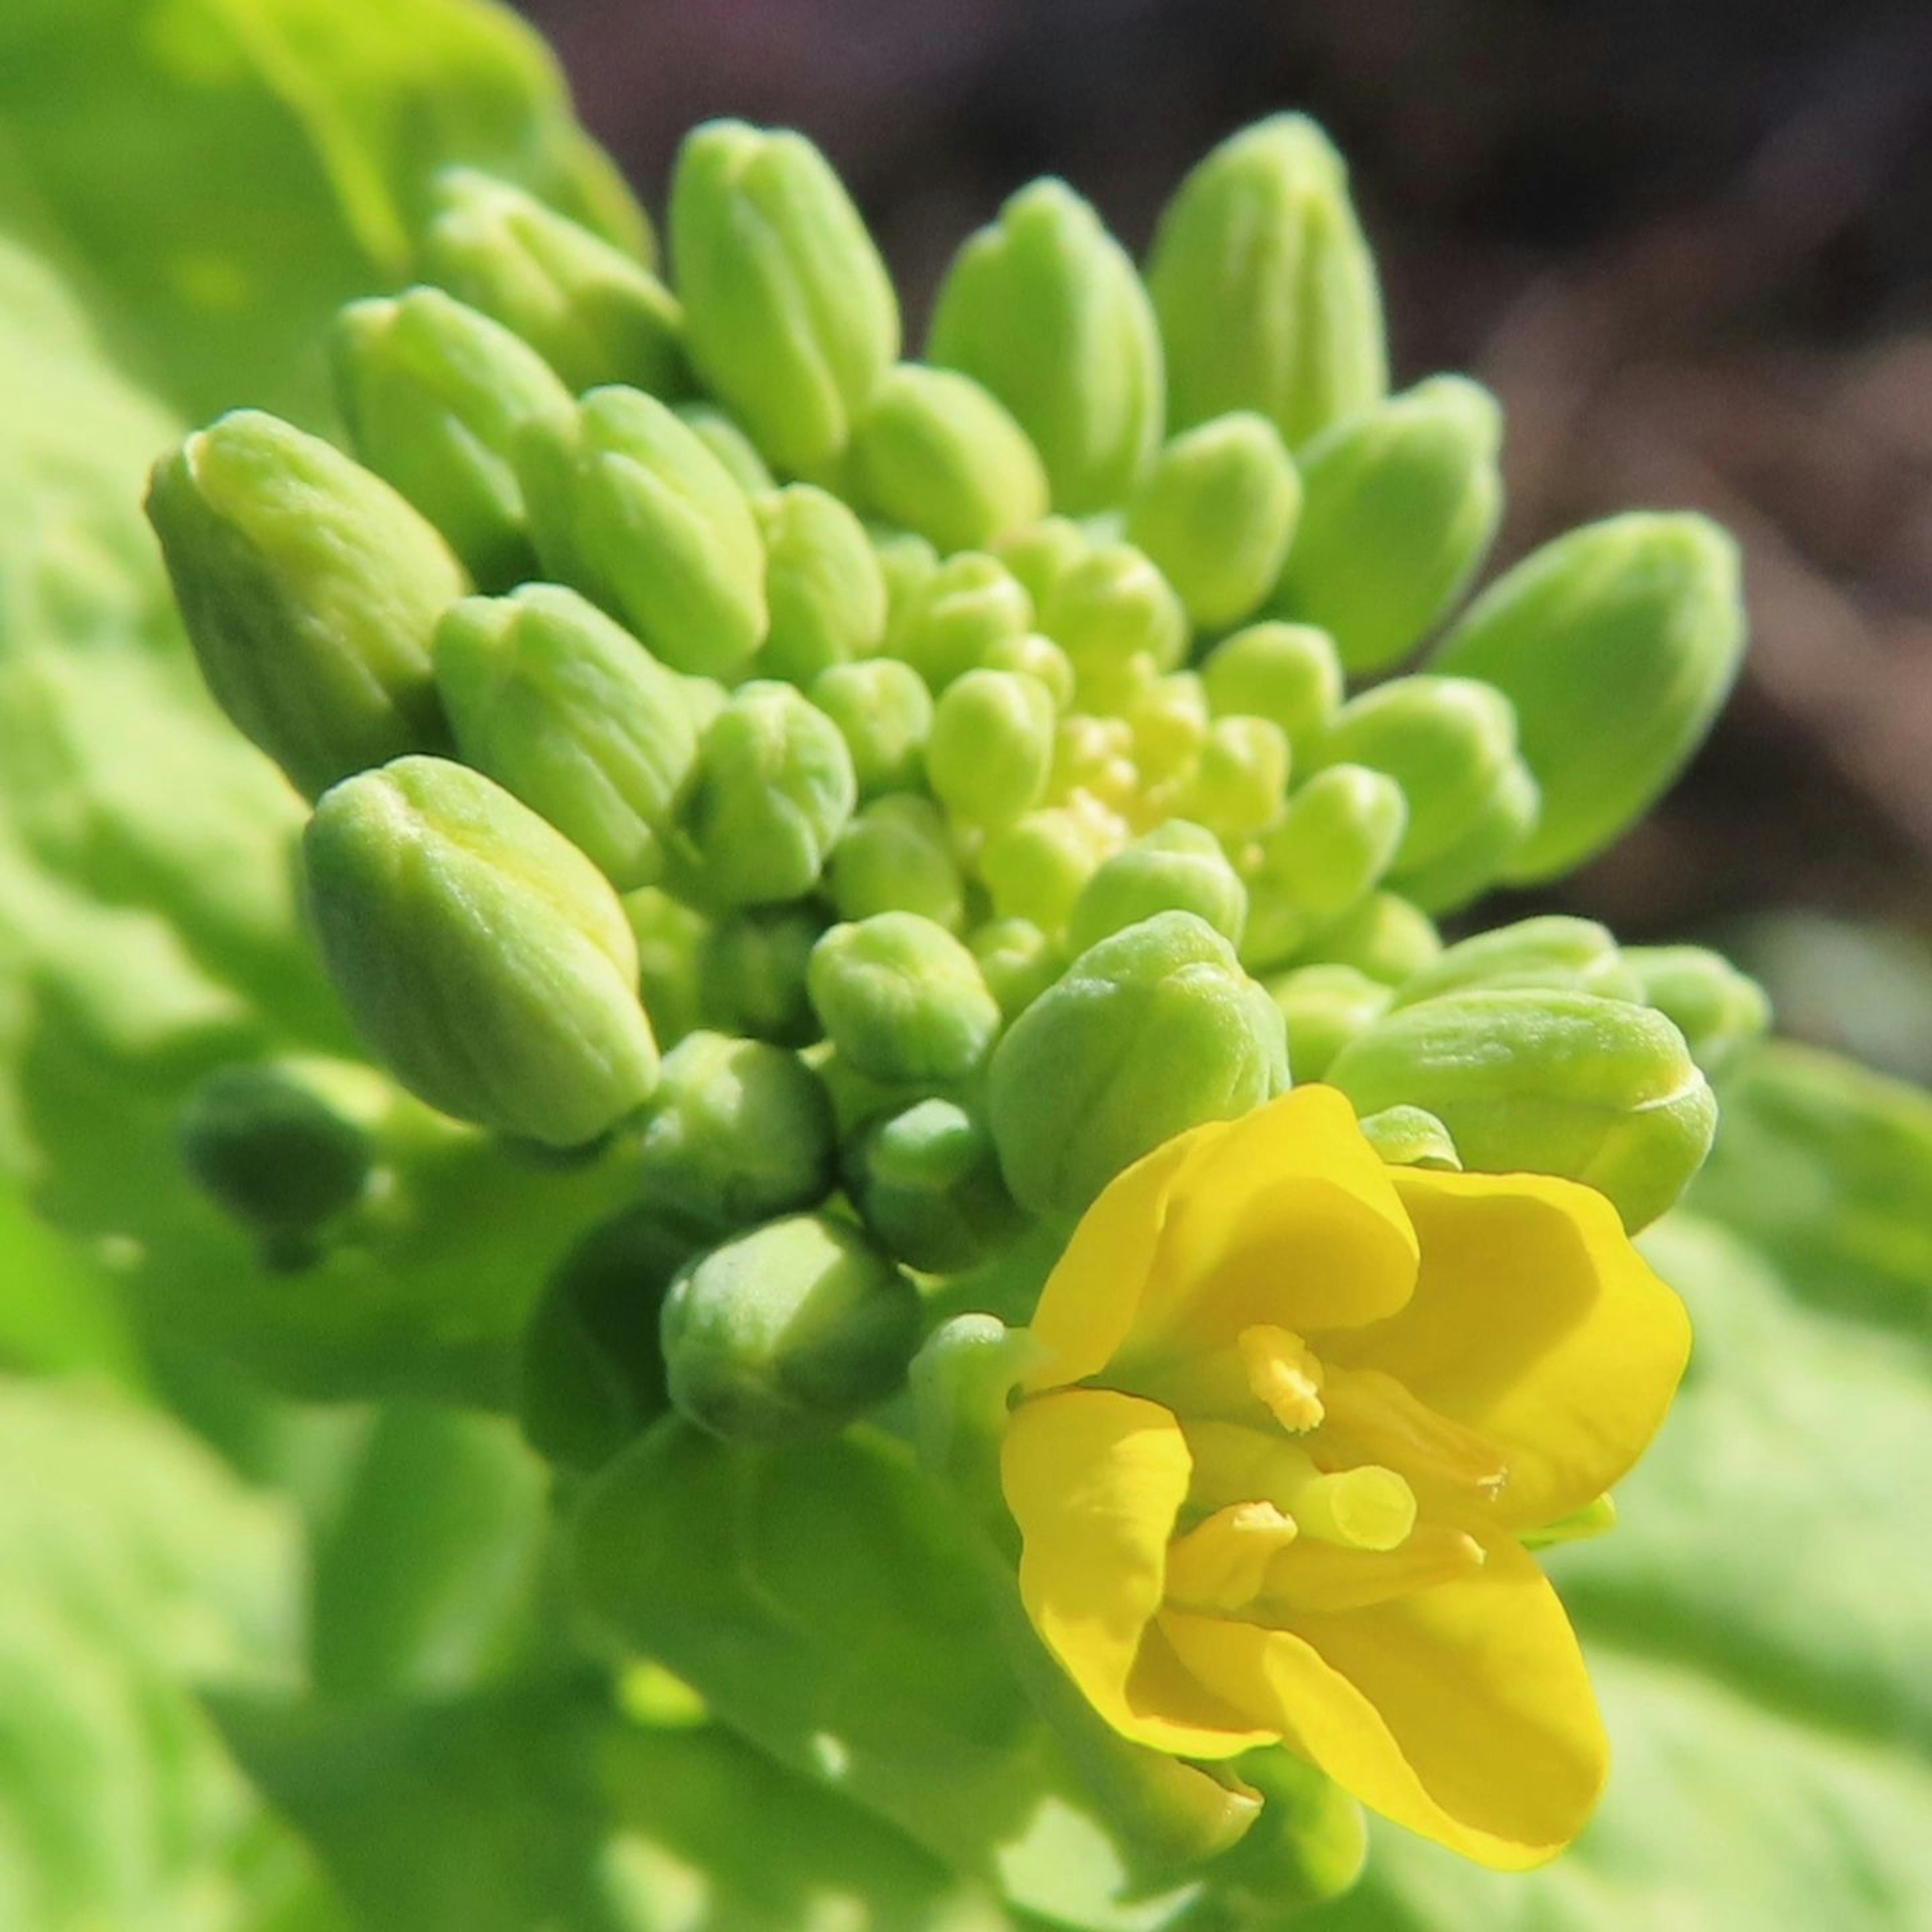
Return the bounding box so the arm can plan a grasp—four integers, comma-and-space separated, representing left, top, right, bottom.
1161, 1538, 1609, 1870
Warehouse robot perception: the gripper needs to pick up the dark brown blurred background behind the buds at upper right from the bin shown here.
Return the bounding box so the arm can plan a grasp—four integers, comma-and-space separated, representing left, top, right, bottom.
522, 0, 1932, 1082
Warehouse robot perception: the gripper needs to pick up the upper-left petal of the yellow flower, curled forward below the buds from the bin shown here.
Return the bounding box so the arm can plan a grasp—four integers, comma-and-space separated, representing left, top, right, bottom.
1124, 1086, 1416, 1354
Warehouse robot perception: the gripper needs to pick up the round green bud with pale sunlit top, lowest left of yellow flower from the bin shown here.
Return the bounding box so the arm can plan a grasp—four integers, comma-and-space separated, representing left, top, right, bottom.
661, 1215, 920, 1441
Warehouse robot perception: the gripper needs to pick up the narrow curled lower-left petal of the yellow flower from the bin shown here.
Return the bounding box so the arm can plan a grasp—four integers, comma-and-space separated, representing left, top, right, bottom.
1001, 1389, 1275, 1758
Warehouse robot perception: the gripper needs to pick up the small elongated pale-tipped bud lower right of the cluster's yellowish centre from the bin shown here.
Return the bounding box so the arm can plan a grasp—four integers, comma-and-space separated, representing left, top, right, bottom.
1242, 765, 1408, 966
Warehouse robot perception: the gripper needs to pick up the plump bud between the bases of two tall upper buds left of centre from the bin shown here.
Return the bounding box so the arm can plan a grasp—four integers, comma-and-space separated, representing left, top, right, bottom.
850, 363, 1047, 554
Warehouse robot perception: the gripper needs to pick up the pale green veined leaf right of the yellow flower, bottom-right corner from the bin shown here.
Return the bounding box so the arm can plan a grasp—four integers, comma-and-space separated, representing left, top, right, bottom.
1310, 1047, 1932, 1932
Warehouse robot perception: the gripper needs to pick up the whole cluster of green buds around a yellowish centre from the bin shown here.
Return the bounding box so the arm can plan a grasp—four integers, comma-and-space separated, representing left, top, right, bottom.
151, 116, 1762, 1433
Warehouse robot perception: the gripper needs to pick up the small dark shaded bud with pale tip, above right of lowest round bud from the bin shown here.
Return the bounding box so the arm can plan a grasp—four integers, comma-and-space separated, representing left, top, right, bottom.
844, 1099, 1020, 1275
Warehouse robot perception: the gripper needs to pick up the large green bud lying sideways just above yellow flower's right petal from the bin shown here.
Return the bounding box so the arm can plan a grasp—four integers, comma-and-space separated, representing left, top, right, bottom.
1327, 989, 1718, 1233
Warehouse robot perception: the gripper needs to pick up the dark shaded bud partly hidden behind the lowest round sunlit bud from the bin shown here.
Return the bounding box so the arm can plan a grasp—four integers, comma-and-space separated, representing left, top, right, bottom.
518, 1201, 709, 1474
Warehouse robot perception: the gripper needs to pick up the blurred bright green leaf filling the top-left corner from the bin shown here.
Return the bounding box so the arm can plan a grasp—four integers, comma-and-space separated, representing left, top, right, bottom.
0, 0, 639, 421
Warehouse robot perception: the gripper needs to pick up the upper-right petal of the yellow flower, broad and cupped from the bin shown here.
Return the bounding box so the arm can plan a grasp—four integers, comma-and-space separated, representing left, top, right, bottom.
1316, 1169, 1691, 1528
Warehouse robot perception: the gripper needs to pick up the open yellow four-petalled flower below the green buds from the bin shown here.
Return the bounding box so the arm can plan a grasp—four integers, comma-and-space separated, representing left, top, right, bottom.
1001, 1086, 1691, 1866
